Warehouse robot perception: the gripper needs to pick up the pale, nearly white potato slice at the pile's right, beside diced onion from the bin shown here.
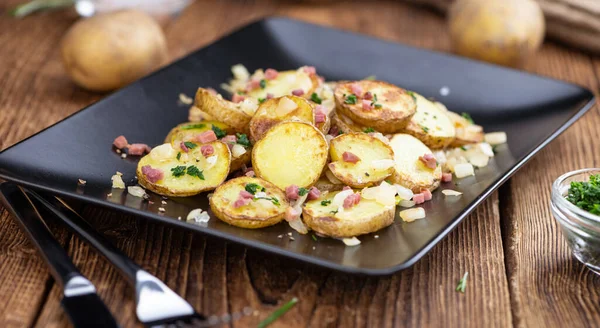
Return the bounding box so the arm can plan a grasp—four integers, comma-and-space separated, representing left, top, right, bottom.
390, 133, 442, 193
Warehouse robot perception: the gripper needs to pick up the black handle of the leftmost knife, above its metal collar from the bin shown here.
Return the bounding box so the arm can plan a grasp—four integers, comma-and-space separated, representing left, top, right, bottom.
0, 182, 81, 286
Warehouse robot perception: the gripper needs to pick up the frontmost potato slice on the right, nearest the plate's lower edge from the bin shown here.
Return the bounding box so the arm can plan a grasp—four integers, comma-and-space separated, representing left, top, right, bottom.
302, 191, 395, 238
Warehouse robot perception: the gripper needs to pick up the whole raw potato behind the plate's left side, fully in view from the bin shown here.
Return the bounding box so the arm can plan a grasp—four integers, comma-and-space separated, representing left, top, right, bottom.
61, 10, 167, 91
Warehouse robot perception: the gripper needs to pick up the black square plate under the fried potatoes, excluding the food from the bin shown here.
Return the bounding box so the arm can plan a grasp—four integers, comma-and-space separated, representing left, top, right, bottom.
0, 18, 594, 275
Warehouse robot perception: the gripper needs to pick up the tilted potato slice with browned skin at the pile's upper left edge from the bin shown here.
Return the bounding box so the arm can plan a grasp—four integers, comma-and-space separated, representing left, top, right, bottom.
195, 88, 258, 132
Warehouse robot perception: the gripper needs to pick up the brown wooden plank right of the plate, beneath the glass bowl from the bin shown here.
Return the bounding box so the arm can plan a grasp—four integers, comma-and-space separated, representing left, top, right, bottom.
500, 44, 600, 327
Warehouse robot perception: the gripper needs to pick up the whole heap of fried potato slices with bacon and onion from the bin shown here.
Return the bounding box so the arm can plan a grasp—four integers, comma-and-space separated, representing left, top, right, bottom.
137, 65, 506, 239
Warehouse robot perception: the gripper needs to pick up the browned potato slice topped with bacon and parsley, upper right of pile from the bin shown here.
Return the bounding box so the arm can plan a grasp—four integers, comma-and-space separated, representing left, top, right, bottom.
335, 80, 417, 133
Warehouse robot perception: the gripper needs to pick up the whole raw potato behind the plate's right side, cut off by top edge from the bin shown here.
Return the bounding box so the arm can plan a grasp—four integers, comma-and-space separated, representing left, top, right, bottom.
448, 0, 545, 67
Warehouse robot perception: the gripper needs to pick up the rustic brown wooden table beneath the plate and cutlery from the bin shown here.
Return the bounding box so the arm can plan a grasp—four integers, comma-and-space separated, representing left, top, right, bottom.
0, 0, 600, 327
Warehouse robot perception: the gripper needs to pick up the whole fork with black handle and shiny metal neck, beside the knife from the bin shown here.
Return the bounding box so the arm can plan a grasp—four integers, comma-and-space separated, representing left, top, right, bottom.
25, 190, 216, 327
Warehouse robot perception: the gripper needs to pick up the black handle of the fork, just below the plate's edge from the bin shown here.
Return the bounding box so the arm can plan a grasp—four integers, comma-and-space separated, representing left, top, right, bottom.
25, 190, 141, 285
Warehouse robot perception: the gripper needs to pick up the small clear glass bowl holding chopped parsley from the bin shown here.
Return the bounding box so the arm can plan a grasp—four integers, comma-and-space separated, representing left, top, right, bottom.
551, 168, 600, 275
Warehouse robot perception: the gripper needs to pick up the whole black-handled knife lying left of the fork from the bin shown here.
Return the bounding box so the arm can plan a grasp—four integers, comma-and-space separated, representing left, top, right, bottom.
0, 182, 119, 328
